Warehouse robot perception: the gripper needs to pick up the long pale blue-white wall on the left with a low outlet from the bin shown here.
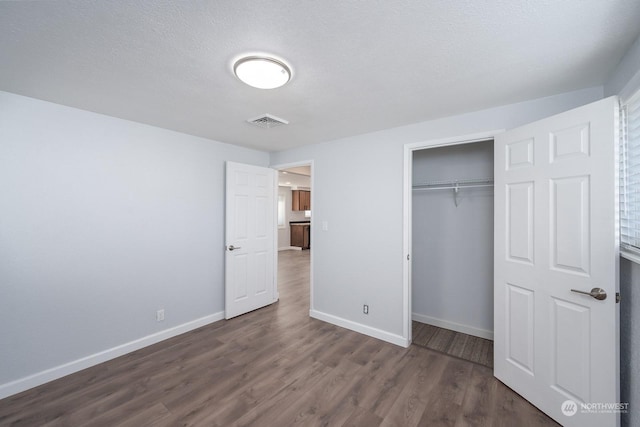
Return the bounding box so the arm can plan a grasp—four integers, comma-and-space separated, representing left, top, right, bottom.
0, 92, 269, 397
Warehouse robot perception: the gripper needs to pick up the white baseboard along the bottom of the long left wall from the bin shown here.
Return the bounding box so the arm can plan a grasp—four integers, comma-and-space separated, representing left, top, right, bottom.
0, 311, 224, 399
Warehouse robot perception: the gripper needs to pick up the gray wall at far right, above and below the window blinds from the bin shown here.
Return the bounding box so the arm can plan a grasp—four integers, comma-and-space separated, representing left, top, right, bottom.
604, 30, 640, 426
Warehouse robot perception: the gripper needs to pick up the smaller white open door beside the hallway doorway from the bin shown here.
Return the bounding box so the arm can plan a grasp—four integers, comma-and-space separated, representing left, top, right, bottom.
225, 162, 277, 319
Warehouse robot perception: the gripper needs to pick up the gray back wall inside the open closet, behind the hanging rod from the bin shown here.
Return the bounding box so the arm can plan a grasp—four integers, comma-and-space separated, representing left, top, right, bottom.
411, 140, 493, 339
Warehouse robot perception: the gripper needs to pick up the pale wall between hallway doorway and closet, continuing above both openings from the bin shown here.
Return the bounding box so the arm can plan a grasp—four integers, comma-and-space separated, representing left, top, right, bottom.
271, 87, 603, 343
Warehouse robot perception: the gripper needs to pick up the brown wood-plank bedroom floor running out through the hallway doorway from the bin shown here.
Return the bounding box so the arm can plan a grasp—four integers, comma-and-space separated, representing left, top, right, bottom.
0, 251, 555, 427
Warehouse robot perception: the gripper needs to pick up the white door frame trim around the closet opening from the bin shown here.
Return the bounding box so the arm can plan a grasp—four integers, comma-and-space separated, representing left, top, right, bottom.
400, 129, 505, 347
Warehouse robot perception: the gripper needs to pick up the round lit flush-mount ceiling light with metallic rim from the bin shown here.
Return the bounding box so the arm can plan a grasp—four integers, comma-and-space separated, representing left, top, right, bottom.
233, 56, 291, 89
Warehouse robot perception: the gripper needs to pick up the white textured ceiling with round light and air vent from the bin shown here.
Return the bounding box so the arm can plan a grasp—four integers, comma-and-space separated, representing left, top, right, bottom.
0, 0, 640, 151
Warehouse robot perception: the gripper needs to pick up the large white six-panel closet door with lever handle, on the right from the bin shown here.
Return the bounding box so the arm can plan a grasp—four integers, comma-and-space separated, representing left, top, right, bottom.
494, 98, 619, 427
